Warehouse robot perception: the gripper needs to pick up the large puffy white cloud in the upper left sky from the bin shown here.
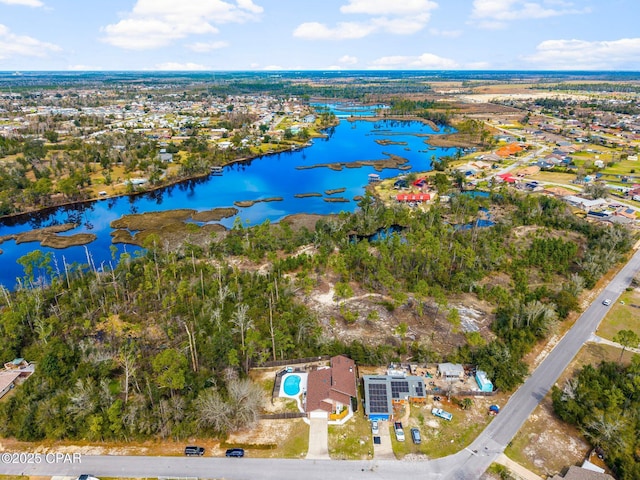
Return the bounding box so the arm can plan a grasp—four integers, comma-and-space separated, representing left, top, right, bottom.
102, 0, 263, 50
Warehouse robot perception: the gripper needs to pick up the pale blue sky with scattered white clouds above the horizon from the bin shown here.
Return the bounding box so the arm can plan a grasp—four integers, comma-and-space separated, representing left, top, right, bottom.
0, 0, 640, 71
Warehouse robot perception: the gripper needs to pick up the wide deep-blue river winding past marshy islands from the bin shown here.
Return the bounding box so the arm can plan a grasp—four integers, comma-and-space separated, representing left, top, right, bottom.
0, 110, 453, 289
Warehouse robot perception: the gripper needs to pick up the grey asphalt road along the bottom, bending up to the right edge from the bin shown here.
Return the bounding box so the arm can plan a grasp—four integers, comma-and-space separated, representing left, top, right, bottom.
0, 251, 640, 480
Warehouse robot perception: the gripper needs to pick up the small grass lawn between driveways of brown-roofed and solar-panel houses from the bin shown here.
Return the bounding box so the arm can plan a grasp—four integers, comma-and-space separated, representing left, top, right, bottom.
329, 412, 373, 460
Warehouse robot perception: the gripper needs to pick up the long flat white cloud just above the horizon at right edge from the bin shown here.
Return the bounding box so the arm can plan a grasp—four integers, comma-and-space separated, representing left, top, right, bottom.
524, 38, 640, 70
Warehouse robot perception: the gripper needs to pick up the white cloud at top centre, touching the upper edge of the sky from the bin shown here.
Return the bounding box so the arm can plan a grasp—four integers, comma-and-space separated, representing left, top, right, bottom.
293, 0, 438, 40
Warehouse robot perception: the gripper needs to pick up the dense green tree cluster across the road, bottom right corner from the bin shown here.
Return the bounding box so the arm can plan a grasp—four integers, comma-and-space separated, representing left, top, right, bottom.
552, 355, 640, 480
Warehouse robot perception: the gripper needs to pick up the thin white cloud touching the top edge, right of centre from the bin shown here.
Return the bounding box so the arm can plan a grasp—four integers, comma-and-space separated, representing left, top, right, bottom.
471, 0, 589, 29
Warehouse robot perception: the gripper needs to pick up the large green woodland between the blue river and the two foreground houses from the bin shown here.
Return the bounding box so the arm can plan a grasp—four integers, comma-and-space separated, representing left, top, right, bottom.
0, 190, 632, 440
